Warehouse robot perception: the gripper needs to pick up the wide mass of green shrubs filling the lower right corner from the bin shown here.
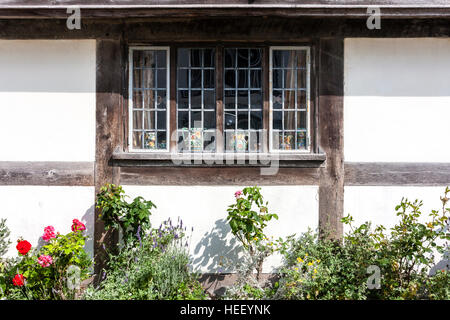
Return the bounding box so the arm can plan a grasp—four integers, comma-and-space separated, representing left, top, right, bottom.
273, 188, 450, 299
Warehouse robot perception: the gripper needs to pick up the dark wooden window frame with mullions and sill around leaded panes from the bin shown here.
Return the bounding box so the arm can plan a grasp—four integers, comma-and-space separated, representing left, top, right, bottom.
123, 41, 325, 161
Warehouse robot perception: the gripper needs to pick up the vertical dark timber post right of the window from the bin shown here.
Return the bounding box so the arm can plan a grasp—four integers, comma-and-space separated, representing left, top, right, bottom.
318, 38, 344, 239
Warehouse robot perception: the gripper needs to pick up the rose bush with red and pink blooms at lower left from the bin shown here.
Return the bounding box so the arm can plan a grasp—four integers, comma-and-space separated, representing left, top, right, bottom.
3, 219, 91, 299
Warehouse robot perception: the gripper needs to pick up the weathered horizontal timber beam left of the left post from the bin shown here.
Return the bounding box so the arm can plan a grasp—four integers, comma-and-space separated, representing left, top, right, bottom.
0, 161, 94, 186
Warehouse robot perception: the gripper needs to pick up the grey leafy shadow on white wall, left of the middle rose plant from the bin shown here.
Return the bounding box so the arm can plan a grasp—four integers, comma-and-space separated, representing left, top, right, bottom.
193, 219, 243, 273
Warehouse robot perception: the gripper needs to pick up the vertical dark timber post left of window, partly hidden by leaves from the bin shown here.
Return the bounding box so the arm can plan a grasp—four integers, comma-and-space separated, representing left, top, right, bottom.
94, 39, 123, 279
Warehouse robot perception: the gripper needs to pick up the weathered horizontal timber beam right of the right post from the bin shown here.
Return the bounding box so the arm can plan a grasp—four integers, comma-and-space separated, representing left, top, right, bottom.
345, 162, 450, 186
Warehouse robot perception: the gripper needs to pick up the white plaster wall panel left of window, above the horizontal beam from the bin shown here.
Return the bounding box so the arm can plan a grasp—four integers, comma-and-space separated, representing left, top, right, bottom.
0, 40, 96, 161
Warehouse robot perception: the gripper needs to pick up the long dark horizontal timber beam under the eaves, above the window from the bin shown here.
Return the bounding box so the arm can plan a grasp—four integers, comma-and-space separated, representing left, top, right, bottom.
0, 17, 450, 40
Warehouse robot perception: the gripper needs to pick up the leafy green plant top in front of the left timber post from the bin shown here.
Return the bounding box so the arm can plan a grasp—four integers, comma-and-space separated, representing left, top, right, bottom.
96, 184, 156, 242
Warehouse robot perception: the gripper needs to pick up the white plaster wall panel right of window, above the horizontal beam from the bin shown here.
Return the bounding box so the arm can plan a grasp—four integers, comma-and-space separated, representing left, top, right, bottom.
344, 38, 450, 162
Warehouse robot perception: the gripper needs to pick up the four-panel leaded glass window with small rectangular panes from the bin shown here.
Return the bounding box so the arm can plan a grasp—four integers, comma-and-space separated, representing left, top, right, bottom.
128, 44, 317, 153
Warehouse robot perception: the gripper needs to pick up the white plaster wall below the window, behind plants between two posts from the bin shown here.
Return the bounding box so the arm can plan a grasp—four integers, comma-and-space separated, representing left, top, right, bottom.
124, 186, 319, 272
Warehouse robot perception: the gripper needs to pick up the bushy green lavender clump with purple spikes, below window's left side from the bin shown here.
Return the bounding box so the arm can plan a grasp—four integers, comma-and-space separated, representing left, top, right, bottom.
85, 220, 205, 300
